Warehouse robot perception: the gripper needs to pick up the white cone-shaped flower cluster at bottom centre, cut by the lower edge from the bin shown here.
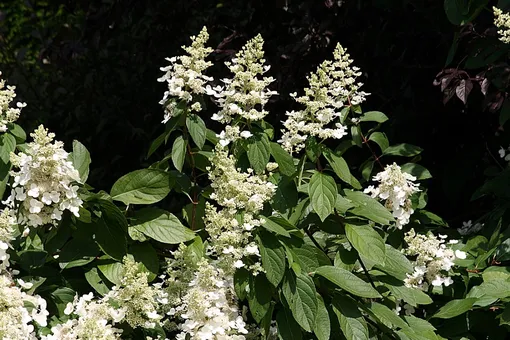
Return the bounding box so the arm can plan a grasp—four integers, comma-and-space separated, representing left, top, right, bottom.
171, 259, 248, 340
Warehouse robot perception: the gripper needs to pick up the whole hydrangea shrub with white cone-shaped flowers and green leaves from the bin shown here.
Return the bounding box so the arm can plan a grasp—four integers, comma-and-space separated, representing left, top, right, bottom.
0, 28, 510, 340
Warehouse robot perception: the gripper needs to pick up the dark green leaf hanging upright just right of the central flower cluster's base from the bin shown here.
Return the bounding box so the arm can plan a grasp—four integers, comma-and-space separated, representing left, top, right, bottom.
257, 232, 285, 287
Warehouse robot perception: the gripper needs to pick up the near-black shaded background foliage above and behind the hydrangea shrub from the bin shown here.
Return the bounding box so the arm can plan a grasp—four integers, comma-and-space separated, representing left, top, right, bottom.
0, 0, 499, 227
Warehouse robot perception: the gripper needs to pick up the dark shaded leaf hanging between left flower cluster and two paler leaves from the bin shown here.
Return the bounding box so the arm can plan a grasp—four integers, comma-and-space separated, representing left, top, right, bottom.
95, 200, 127, 261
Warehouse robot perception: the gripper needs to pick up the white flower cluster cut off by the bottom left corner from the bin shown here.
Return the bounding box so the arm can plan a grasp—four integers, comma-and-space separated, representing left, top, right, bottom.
0, 273, 49, 340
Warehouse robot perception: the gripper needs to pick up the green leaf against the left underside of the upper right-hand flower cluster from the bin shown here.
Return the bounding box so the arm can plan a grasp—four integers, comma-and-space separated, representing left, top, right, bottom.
344, 190, 394, 225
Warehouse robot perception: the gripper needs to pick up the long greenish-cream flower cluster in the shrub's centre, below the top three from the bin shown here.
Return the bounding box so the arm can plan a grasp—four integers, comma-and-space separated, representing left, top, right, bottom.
205, 147, 276, 273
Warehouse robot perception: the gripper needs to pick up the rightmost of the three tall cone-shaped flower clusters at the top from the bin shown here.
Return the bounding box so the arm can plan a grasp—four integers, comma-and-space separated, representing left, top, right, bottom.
278, 44, 368, 153
